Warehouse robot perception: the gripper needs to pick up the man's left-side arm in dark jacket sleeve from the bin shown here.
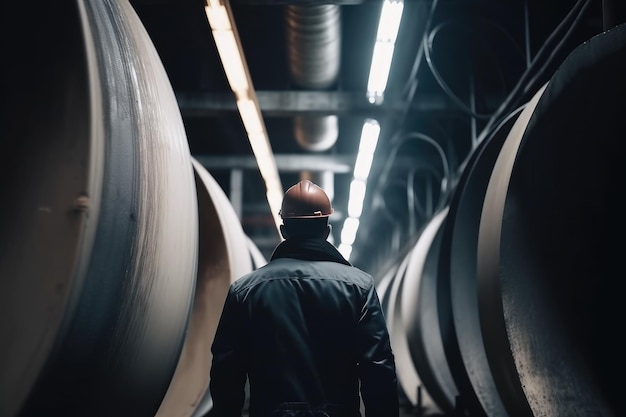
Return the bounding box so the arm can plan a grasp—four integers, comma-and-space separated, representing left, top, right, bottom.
208, 287, 246, 417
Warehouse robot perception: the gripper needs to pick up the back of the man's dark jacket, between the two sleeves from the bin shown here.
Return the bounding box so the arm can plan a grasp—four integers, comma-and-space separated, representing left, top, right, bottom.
237, 258, 368, 410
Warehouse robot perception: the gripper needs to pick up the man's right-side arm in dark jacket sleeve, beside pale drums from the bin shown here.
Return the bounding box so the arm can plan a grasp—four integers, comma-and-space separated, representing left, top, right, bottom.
357, 282, 400, 417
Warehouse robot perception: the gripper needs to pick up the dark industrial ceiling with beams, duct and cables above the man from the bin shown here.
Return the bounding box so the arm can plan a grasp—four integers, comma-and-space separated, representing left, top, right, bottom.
131, 0, 609, 273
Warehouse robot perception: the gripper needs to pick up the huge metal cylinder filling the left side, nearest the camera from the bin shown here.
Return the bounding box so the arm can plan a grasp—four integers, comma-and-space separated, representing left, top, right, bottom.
0, 0, 198, 417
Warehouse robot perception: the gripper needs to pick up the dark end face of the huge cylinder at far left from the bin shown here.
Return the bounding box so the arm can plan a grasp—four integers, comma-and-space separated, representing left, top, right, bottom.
0, 2, 104, 416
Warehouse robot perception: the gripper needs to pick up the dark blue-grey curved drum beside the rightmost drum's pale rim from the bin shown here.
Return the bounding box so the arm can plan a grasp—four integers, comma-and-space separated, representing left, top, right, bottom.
437, 107, 523, 417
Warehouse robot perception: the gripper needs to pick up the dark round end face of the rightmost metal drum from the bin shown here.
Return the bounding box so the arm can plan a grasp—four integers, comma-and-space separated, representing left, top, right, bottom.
485, 25, 626, 417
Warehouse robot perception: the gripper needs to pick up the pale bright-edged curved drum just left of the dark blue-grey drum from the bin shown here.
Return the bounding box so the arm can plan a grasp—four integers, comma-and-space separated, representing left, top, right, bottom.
396, 207, 458, 413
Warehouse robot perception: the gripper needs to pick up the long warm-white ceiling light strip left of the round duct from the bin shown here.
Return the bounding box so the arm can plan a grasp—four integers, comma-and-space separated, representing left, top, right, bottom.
204, 0, 283, 232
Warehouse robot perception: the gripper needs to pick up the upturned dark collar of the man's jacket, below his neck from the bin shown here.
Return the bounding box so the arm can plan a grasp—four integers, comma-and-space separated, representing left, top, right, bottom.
270, 237, 352, 266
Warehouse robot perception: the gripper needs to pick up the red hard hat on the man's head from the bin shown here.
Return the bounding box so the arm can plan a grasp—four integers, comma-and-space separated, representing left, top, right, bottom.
279, 180, 333, 219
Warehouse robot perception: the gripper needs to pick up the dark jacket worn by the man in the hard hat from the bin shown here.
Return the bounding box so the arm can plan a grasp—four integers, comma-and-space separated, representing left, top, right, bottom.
209, 238, 399, 417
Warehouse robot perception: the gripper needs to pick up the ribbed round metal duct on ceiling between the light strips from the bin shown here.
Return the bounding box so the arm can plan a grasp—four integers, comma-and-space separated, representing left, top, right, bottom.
285, 4, 341, 151
